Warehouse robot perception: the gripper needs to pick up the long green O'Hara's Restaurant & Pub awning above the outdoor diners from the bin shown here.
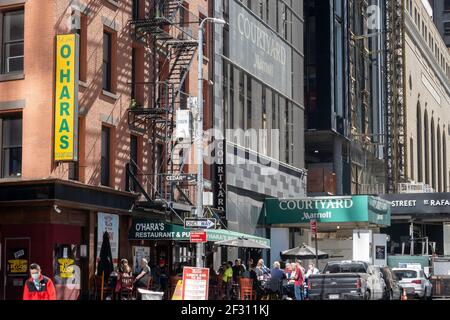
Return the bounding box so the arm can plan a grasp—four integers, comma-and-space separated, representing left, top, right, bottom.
128, 218, 270, 246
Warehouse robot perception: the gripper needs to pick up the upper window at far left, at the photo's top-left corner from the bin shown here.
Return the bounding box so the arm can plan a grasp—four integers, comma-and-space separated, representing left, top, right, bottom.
0, 10, 24, 74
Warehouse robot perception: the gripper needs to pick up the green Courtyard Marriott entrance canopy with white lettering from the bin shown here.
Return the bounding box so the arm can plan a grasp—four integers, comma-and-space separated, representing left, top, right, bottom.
265, 196, 391, 226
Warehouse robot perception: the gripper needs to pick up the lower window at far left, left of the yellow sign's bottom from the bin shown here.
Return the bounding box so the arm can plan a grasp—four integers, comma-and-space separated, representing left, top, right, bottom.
0, 115, 22, 178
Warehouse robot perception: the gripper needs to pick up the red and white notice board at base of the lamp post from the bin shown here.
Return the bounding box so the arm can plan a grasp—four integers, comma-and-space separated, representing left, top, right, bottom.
182, 267, 209, 300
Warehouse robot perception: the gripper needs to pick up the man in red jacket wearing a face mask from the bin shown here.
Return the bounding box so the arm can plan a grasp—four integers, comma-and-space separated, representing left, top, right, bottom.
23, 263, 56, 300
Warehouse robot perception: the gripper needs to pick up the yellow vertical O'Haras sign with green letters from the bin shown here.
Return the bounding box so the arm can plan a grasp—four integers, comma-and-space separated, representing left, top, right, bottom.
55, 34, 79, 161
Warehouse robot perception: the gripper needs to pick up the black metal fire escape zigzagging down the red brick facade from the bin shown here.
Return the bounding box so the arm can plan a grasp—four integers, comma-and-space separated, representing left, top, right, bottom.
126, 0, 199, 218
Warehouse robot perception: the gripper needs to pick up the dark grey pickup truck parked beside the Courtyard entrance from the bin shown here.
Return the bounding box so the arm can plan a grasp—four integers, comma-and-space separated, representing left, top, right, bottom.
308, 261, 386, 300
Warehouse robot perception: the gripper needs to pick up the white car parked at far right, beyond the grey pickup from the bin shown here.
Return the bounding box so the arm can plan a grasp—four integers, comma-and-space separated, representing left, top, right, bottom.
392, 268, 433, 299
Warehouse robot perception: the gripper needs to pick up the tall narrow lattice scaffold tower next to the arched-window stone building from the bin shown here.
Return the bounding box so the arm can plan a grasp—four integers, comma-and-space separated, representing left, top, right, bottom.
385, 0, 408, 193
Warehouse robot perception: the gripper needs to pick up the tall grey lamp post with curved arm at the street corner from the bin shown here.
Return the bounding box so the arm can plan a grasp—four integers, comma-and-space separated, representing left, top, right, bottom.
195, 17, 226, 268
